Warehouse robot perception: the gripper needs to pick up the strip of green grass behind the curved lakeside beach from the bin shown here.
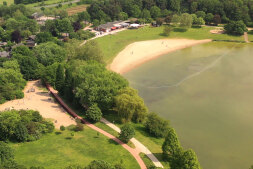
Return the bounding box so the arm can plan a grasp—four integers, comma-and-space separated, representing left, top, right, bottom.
95, 26, 244, 64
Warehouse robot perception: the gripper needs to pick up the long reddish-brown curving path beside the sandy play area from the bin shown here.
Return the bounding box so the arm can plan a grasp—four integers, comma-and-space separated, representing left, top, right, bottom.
46, 84, 147, 169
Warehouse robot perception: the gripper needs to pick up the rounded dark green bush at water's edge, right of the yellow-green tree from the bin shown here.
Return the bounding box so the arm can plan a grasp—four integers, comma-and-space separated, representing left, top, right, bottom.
145, 113, 169, 137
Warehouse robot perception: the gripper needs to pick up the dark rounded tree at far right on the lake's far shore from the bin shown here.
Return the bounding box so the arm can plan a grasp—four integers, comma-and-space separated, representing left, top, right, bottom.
224, 21, 248, 35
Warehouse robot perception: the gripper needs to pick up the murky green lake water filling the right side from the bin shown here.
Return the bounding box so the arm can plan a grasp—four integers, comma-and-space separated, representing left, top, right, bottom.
124, 42, 253, 169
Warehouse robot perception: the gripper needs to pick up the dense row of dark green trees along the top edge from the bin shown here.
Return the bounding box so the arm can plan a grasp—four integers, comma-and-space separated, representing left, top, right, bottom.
87, 0, 253, 24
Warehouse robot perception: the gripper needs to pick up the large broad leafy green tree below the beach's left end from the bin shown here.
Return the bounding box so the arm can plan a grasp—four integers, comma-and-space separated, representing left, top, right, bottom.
73, 62, 128, 111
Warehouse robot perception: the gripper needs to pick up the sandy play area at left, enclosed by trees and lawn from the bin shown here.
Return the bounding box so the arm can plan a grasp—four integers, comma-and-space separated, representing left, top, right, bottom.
0, 81, 76, 129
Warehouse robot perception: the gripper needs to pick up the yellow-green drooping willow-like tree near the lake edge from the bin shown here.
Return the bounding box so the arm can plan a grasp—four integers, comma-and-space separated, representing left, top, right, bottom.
115, 88, 148, 123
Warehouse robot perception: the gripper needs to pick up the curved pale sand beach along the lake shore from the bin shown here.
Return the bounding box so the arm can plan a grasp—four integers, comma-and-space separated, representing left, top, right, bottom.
109, 39, 212, 74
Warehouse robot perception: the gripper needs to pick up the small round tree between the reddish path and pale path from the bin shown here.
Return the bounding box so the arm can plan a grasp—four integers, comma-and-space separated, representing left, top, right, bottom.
119, 124, 135, 143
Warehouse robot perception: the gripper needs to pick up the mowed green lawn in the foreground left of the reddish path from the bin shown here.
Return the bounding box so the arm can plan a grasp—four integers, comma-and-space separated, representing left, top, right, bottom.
12, 126, 139, 169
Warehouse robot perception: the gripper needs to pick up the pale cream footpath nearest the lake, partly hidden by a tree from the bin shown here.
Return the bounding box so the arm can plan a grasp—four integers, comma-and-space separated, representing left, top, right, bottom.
101, 118, 163, 168
